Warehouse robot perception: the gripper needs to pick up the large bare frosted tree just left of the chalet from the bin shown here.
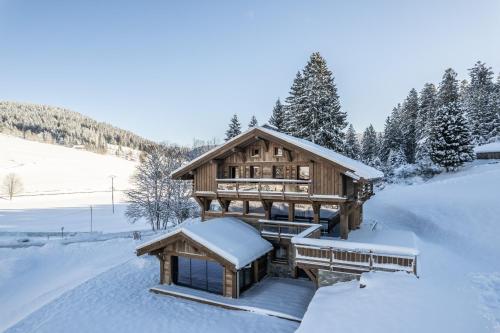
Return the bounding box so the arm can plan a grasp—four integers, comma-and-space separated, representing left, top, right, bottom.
125, 145, 194, 230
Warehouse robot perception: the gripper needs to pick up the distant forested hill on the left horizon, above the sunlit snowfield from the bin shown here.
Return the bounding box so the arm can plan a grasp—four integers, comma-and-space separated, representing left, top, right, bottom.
0, 102, 154, 153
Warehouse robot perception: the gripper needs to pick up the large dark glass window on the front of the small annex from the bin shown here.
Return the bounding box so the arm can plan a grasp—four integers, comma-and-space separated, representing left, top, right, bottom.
172, 256, 224, 294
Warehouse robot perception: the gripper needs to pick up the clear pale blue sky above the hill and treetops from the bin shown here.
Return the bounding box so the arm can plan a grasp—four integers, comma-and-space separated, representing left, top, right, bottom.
0, 0, 500, 144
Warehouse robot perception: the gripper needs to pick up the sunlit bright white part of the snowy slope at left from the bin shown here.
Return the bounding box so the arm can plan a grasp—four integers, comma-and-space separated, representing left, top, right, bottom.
0, 134, 136, 209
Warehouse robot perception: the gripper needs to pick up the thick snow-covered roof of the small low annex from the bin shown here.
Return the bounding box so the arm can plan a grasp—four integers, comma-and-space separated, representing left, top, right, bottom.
137, 217, 273, 269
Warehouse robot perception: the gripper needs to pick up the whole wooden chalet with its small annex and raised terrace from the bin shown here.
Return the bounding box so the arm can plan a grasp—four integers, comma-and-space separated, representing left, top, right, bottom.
137, 127, 422, 297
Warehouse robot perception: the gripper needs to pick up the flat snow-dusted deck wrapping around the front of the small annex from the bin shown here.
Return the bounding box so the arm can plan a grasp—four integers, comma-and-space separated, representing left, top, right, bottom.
151, 277, 315, 321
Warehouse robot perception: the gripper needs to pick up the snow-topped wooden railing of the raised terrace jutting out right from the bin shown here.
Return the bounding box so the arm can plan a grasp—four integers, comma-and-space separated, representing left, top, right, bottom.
292, 237, 418, 275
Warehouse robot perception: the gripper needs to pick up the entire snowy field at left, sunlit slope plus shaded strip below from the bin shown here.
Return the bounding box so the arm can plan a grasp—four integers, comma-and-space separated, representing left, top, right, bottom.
0, 134, 153, 232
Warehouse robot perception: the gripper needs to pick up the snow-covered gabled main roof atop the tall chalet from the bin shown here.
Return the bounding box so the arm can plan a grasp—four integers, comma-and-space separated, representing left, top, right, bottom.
172, 126, 384, 180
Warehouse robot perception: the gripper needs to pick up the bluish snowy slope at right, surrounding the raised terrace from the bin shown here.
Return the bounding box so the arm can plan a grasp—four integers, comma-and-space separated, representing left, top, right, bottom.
298, 161, 500, 333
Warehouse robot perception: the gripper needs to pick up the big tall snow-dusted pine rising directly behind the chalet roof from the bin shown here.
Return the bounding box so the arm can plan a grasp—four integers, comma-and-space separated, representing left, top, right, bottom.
293, 52, 347, 151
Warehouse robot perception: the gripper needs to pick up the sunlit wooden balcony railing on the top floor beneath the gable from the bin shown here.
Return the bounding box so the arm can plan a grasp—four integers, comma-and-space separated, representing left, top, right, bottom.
217, 178, 311, 197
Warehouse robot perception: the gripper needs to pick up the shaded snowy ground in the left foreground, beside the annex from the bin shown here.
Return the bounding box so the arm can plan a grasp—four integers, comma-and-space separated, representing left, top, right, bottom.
0, 239, 298, 333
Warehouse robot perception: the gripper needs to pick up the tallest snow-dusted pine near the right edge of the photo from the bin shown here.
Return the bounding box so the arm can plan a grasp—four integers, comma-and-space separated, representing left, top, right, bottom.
464, 61, 500, 144
